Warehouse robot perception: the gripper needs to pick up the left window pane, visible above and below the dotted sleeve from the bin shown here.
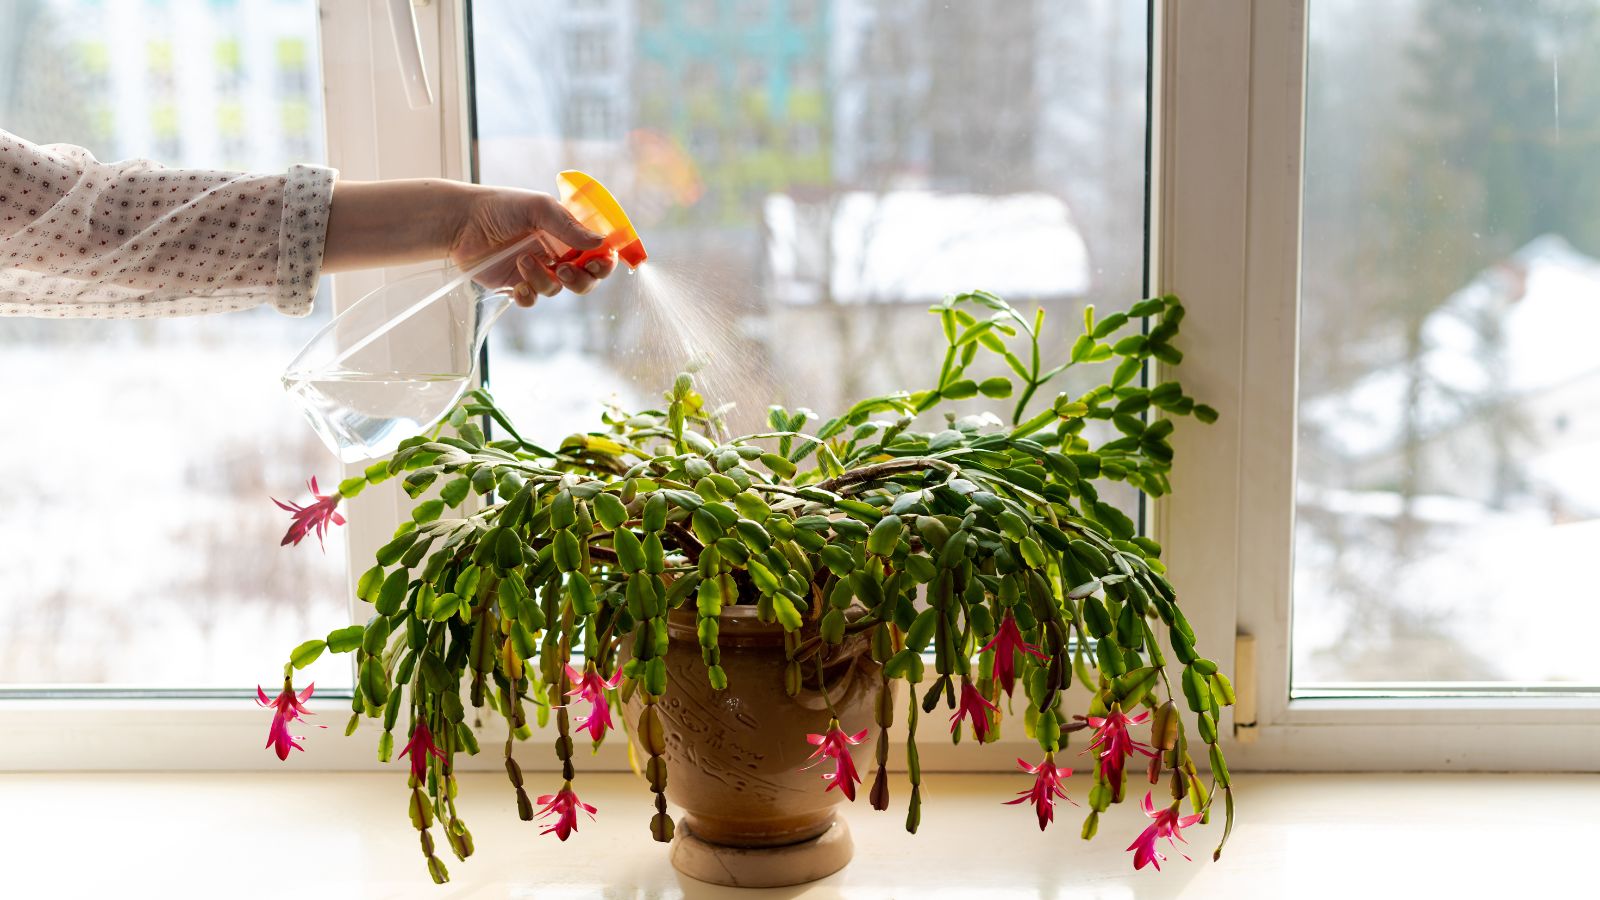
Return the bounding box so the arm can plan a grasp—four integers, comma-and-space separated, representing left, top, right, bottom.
0, 0, 350, 689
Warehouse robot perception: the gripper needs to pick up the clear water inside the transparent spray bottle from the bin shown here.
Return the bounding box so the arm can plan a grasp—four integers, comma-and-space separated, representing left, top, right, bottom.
283, 372, 472, 463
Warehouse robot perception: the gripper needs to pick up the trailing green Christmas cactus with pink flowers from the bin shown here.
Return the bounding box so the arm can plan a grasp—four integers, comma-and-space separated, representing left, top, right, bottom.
261, 291, 1234, 881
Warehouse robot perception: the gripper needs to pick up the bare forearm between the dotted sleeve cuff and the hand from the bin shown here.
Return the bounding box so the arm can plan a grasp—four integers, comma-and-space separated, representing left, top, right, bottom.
322, 178, 483, 272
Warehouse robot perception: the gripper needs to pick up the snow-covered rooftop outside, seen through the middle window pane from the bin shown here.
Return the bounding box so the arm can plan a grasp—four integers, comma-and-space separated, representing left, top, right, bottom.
763, 191, 1090, 304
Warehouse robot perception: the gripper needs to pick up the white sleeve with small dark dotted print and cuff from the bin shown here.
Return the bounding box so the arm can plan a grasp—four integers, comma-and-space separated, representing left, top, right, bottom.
0, 131, 336, 319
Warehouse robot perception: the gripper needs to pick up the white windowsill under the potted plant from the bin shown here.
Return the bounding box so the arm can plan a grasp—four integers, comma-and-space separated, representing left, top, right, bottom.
0, 772, 1600, 900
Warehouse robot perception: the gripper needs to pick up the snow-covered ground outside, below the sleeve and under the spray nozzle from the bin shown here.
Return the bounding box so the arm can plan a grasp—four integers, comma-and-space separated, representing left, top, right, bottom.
0, 307, 642, 687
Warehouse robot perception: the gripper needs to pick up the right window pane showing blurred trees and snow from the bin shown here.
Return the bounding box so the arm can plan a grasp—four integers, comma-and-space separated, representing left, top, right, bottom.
1294, 0, 1600, 690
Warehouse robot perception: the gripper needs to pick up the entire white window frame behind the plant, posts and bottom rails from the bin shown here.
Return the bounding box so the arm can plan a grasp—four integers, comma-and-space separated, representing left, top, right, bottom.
15, 0, 1600, 772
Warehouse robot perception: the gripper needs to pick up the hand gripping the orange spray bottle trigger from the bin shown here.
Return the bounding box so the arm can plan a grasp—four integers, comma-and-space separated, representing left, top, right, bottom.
450, 187, 616, 306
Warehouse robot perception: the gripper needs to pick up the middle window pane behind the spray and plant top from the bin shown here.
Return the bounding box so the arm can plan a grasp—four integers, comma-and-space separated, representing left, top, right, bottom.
472, 0, 1147, 490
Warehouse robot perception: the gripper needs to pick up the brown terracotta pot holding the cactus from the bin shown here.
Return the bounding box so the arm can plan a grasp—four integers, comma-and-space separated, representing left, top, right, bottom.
629, 605, 882, 887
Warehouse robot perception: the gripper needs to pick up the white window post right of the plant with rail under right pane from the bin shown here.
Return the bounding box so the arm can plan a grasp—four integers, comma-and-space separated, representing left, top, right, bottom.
1152, 0, 1600, 772
